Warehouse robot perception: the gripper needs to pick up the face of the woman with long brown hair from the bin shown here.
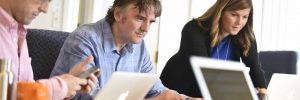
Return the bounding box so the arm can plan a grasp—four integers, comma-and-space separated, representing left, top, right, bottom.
221, 8, 251, 37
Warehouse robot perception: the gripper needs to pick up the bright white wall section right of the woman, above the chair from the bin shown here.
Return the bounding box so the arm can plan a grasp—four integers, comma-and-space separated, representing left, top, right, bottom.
260, 0, 300, 51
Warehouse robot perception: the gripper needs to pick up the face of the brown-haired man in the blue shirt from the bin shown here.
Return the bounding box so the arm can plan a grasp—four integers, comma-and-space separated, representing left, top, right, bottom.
115, 4, 155, 44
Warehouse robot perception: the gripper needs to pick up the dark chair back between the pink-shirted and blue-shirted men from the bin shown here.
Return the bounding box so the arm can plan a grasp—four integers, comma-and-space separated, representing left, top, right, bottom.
26, 29, 69, 80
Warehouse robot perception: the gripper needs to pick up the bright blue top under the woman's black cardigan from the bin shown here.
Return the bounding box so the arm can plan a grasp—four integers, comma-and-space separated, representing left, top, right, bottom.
211, 36, 233, 60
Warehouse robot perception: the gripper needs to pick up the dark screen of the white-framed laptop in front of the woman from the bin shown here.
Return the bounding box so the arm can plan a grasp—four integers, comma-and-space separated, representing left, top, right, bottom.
201, 68, 253, 100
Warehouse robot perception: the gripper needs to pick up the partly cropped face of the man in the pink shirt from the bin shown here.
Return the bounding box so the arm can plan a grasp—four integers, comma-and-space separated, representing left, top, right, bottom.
12, 0, 49, 25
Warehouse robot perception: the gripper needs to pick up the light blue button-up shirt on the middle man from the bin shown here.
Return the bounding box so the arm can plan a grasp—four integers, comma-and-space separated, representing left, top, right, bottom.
51, 19, 167, 100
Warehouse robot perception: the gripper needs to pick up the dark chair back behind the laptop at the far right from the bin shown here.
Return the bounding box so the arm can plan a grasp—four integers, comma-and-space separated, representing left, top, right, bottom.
259, 51, 298, 85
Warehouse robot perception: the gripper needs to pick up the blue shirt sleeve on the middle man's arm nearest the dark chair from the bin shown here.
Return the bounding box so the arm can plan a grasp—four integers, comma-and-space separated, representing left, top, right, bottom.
51, 30, 98, 100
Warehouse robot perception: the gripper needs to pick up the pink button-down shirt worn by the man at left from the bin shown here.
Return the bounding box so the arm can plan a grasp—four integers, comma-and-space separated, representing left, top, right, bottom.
0, 7, 67, 100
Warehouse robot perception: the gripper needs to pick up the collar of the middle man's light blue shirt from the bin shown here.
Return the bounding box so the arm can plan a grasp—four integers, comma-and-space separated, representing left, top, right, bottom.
101, 18, 134, 53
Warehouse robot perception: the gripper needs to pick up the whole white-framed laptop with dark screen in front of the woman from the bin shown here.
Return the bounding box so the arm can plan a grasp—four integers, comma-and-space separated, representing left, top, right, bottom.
190, 56, 258, 100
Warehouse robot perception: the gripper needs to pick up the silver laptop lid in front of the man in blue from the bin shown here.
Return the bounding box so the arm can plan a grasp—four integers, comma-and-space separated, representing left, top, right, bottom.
94, 72, 158, 100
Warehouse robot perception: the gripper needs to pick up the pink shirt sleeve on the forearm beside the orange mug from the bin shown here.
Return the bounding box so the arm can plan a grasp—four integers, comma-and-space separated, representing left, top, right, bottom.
36, 77, 68, 100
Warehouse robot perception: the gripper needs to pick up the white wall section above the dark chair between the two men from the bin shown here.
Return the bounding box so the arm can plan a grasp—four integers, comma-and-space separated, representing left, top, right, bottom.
27, 0, 79, 32
